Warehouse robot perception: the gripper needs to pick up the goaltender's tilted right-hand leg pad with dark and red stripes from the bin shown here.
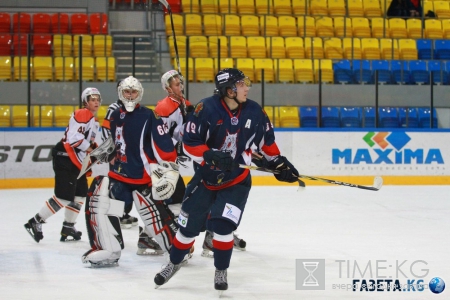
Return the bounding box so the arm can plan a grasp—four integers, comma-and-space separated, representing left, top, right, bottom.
133, 191, 178, 252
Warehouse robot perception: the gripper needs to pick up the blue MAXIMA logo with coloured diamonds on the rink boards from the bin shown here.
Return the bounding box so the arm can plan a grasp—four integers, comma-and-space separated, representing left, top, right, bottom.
332, 131, 444, 165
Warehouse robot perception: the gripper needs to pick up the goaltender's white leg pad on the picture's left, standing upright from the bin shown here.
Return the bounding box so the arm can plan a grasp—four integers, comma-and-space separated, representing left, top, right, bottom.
81, 177, 124, 266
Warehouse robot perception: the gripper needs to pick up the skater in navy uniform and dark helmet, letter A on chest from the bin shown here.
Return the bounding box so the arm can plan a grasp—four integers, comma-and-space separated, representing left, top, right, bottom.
154, 68, 298, 293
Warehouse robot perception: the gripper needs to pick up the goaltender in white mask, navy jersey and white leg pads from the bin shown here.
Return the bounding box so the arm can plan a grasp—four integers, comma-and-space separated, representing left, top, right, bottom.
82, 76, 179, 266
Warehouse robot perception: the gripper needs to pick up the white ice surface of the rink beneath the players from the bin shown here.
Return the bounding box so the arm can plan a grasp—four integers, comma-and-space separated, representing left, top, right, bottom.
0, 185, 450, 300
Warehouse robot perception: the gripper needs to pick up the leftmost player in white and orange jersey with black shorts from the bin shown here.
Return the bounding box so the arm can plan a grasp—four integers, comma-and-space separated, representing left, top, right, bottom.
25, 87, 102, 243
